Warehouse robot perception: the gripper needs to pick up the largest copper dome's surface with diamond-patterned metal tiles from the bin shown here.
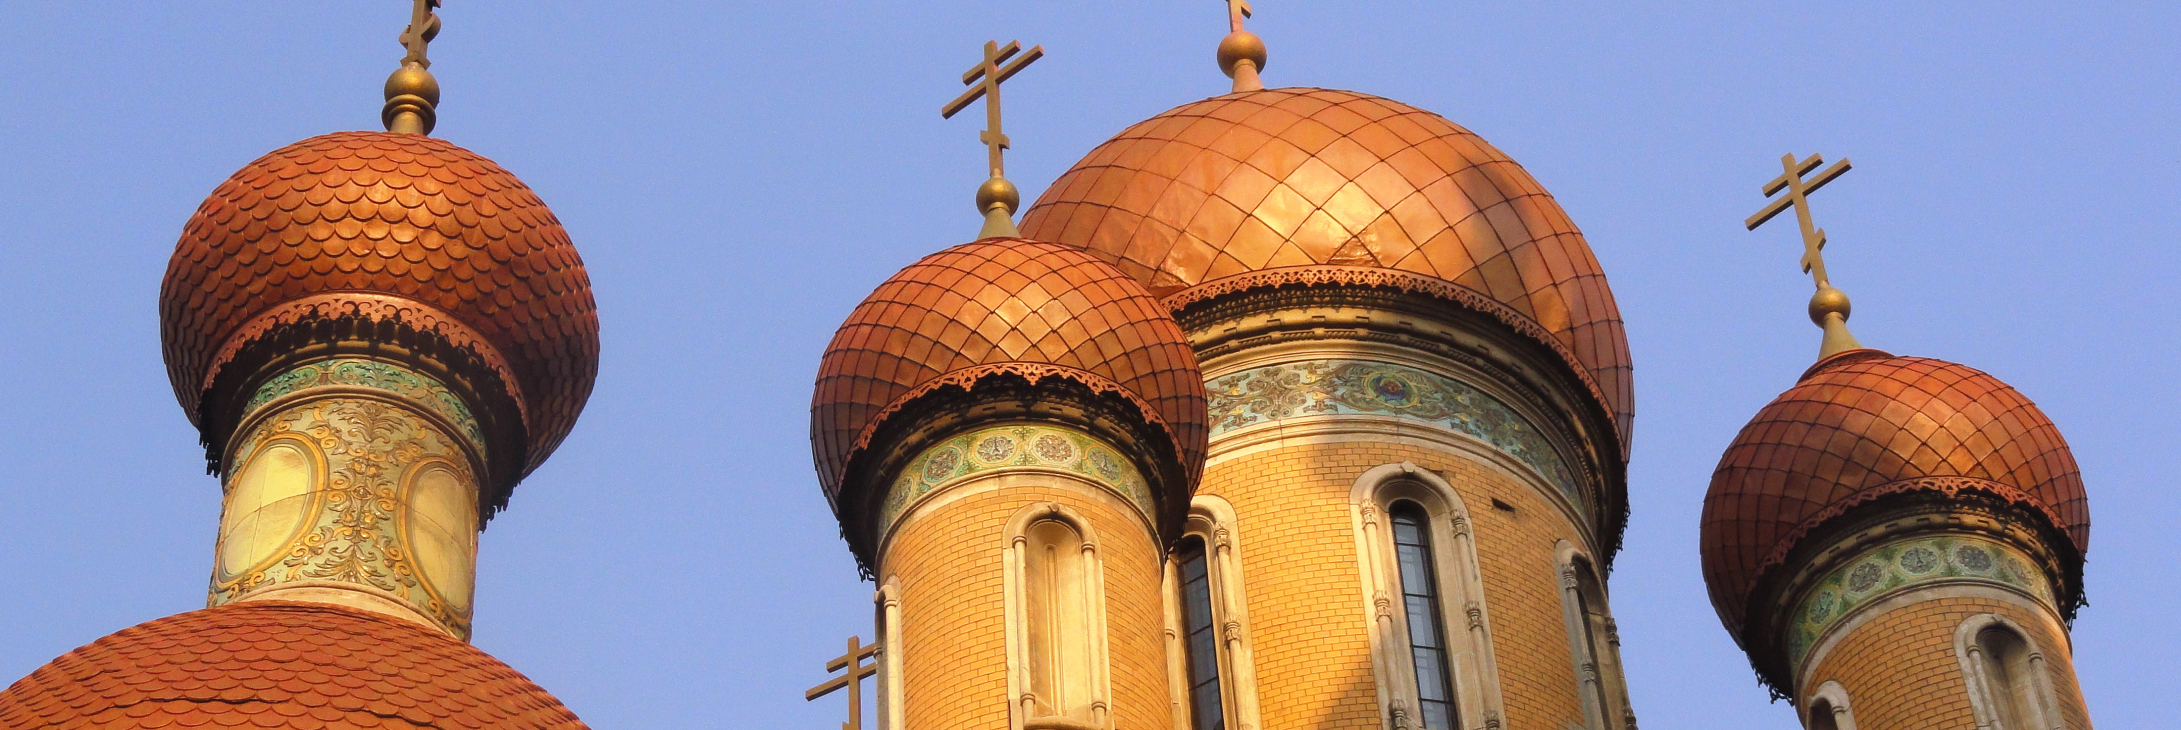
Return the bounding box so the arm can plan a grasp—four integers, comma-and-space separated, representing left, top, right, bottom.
1023, 89, 1634, 458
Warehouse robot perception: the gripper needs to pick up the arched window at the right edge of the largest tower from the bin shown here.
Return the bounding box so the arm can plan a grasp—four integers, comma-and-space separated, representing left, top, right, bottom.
1559, 555, 1636, 730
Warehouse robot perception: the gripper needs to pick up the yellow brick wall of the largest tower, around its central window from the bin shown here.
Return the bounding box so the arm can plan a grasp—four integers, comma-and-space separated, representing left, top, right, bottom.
1197, 442, 1583, 730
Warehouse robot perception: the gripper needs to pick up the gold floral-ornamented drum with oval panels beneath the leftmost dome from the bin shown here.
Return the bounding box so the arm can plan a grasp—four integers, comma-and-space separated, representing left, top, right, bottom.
209, 399, 478, 636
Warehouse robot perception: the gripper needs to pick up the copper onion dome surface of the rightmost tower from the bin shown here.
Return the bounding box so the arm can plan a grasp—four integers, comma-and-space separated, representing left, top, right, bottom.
1703, 351, 2089, 632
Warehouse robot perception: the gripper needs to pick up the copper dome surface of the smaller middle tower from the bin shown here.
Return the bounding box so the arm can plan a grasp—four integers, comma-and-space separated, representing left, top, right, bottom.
811, 238, 1206, 499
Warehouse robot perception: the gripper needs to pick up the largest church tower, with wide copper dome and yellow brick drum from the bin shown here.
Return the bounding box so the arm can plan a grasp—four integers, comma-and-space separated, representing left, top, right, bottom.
1023, 10, 1636, 730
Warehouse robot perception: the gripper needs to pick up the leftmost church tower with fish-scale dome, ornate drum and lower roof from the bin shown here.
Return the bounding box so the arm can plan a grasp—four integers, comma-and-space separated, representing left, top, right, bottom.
0, 0, 598, 730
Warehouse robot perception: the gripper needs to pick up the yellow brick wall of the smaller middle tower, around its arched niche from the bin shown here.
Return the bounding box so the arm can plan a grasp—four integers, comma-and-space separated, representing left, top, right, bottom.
885, 479, 1173, 730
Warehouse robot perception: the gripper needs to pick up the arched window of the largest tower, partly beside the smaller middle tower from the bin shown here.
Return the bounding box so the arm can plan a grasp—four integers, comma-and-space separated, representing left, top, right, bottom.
1167, 495, 1258, 730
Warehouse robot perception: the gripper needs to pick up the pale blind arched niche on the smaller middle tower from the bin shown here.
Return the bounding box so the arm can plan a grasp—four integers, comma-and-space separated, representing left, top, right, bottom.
1005, 503, 1108, 730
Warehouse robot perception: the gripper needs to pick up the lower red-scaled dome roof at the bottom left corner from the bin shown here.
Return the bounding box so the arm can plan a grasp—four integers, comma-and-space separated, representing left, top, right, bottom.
0, 601, 585, 730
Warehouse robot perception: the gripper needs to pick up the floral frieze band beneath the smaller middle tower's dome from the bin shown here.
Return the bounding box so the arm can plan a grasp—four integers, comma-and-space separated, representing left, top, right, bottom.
879, 425, 1156, 534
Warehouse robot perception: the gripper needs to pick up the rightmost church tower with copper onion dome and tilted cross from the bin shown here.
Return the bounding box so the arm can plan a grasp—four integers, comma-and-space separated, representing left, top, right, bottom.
1703, 155, 2089, 730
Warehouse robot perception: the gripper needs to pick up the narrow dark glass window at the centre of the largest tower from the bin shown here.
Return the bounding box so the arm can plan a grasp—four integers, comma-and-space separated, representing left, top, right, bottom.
1387, 501, 1459, 730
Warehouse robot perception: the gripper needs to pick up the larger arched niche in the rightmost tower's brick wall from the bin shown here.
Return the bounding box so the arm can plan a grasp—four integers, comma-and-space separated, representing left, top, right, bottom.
1954, 615, 2061, 730
